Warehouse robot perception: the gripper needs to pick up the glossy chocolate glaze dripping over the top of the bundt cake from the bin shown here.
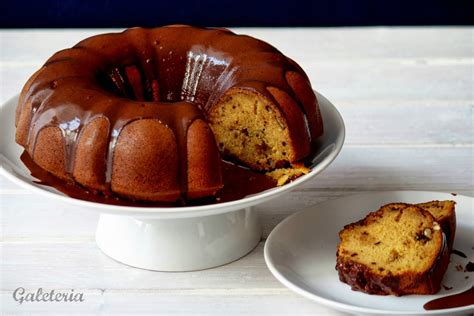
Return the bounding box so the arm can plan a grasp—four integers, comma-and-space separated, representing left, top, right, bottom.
19, 27, 318, 200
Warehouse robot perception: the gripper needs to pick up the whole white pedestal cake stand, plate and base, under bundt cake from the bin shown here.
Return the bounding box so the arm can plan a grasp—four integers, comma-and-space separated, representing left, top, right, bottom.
0, 94, 345, 271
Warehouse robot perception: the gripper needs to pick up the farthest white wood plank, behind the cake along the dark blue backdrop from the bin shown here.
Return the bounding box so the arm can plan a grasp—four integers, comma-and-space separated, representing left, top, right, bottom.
0, 27, 473, 63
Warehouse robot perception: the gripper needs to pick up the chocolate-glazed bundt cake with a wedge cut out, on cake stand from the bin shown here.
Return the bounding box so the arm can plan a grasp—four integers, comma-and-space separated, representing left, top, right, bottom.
16, 26, 323, 202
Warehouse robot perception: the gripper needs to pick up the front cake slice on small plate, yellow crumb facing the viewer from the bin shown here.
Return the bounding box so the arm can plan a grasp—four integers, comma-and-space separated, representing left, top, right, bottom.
336, 203, 449, 296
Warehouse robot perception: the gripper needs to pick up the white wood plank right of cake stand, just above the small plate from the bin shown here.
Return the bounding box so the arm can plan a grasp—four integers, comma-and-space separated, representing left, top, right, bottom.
299, 146, 474, 192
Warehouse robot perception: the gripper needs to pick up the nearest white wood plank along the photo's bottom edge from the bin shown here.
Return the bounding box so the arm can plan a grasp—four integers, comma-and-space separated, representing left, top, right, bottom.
0, 289, 348, 316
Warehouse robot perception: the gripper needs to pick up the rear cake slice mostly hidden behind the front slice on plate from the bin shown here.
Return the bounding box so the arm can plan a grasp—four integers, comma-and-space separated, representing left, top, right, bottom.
416, 200, 456, 251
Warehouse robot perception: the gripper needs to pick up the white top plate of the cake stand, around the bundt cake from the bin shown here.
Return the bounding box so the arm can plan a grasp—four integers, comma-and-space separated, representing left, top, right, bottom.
0, 91, 345, 218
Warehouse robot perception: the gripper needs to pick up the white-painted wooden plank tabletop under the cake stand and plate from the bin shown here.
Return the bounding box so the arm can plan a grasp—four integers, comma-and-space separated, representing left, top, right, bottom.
0, 27, 474, 315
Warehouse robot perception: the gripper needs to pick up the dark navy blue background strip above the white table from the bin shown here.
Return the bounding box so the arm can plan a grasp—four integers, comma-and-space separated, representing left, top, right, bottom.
0, 0, 474, 28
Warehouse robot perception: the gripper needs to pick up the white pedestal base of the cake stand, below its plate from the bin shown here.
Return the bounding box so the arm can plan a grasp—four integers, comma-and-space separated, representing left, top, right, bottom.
96, 207, 261, 271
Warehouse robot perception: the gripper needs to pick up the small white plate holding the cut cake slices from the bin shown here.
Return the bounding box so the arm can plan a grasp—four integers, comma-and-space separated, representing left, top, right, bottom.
264, 191, 474, 315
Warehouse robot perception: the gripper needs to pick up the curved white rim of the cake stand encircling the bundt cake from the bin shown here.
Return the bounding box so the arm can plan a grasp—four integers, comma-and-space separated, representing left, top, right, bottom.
0, 90, 346, 218
